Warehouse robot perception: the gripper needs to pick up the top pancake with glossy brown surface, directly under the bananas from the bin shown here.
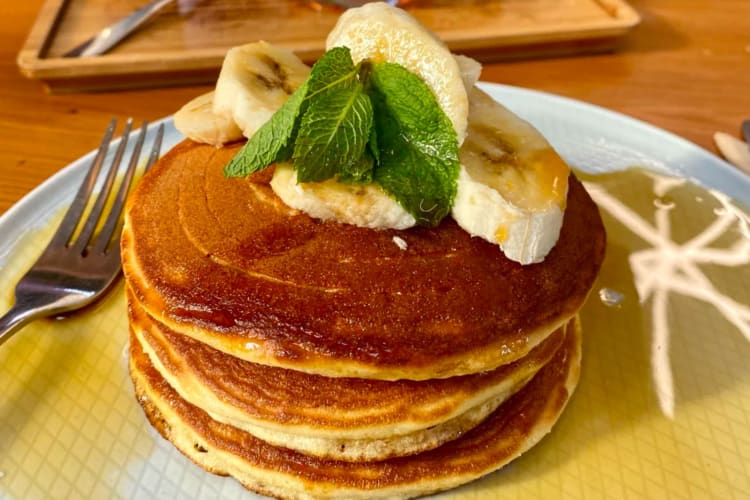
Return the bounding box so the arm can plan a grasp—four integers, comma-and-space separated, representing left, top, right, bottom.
122, 141, 604, 380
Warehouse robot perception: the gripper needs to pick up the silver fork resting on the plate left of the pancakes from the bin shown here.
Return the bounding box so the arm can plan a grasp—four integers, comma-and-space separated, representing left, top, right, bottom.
0, 119, 164, 345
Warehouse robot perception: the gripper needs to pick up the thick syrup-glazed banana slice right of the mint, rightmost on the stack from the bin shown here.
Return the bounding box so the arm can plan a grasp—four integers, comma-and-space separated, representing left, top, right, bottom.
451, 87, 570, 264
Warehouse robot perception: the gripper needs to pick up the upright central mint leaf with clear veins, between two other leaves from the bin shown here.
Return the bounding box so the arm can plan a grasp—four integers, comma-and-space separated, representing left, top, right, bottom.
292, 47, 373, 182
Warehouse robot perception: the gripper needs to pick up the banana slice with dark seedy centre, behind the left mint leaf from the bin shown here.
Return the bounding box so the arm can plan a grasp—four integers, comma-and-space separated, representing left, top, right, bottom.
213, 42, 310, 138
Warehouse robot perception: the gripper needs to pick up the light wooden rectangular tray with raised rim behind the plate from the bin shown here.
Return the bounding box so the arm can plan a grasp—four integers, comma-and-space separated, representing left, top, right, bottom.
18, 0, 640, 92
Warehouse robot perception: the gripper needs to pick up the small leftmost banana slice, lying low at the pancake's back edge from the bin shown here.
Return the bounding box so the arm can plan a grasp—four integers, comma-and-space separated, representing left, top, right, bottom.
174, 91, 242, 147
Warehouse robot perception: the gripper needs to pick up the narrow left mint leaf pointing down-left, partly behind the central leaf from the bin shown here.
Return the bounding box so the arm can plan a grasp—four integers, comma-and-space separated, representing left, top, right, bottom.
224, 84, 308, 177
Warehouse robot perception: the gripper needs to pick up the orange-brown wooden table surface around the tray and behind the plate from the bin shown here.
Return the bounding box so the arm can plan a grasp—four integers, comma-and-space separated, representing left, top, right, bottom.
0, 0, 750, 214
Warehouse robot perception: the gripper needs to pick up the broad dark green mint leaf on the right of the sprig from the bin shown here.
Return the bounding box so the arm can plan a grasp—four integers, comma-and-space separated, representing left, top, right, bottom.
369, 62, 459, 226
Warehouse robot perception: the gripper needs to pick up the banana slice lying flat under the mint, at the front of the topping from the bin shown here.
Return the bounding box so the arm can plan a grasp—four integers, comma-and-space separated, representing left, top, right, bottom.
271, 163, 417, 229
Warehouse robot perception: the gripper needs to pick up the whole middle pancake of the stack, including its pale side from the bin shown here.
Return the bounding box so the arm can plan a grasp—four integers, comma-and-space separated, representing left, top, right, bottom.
128, 286, 573, 461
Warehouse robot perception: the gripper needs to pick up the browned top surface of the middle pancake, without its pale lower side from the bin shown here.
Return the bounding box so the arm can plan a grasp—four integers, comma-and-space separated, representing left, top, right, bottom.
129, 288, 574, 439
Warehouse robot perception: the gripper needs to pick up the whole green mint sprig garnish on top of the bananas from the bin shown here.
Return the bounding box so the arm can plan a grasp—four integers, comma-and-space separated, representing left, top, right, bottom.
224, 47, 459, 226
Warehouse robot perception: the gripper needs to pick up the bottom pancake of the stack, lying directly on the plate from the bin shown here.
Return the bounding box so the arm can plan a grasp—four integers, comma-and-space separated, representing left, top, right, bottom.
130, 314, 581, 498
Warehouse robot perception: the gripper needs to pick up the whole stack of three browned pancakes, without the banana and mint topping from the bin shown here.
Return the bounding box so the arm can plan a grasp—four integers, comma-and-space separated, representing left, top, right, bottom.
122, 141, 604, 498
